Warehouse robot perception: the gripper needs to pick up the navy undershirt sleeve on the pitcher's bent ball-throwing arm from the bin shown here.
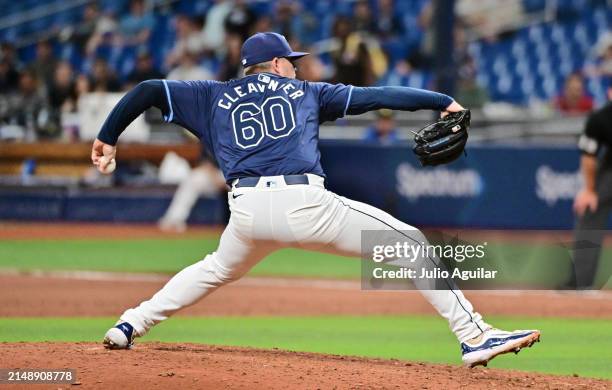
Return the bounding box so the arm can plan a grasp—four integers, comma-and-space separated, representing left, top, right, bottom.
97, 80, 168, 145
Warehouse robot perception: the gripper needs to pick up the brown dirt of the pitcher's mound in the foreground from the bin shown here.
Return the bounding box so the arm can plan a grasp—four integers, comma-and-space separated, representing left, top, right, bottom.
0, 343, 612, 390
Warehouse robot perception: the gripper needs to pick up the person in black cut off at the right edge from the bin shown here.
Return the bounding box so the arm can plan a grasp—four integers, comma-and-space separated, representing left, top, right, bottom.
564, 88, 612, 289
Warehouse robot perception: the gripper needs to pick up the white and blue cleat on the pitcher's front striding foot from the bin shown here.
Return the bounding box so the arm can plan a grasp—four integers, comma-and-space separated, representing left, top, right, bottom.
461, 328, 540, 367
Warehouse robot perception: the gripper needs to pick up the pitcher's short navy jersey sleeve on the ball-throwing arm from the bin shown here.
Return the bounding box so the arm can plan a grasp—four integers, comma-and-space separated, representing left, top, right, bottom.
162, 80, 217, 138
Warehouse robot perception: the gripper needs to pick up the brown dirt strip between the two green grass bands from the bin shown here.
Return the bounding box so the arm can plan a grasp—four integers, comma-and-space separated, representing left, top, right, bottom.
0, 273, 612, 318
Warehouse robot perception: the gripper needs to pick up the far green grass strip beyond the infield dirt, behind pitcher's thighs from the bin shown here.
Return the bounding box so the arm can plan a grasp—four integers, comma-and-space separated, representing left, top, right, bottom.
0, 238, 612, 288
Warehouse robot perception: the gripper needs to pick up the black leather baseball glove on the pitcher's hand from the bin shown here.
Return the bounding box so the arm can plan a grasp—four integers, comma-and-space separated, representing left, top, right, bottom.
412, 110, 470, 166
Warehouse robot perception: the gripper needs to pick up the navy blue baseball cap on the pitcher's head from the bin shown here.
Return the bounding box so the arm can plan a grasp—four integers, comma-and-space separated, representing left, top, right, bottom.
240, 32, 310, 68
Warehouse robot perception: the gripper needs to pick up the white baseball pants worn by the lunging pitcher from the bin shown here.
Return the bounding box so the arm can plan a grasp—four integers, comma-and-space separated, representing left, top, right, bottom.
121, 175, 489, 341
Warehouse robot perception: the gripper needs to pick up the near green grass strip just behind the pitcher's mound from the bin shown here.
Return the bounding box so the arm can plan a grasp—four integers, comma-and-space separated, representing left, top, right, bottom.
0, 316, 612, 378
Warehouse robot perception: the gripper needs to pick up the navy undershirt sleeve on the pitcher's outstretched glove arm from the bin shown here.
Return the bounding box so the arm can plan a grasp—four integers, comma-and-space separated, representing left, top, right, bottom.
347, 87, 456, 115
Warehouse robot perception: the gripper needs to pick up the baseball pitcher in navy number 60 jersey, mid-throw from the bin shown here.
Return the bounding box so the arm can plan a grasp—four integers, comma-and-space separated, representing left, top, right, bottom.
92, 32, 540, 366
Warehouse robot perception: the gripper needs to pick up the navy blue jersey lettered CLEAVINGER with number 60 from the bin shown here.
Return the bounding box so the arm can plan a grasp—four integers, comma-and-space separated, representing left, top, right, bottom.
163, 73, 353, 182
